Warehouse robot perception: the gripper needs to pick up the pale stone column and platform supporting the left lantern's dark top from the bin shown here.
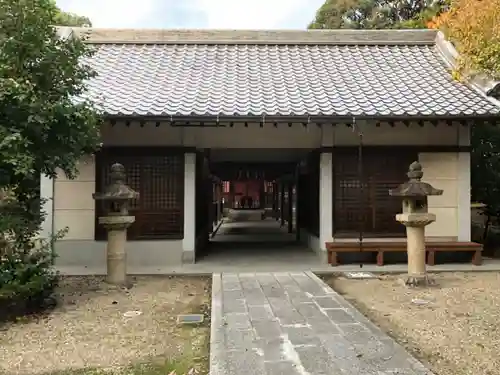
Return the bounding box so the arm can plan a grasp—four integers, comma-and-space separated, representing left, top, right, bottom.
99, 216, 135, 285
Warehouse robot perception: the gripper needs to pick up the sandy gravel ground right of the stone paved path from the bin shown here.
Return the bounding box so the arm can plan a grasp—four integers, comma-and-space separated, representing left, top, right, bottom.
326, 272, 500, 375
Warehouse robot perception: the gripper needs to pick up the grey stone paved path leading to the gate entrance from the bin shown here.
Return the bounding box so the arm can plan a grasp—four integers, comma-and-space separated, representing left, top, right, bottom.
210, 272, 432, 375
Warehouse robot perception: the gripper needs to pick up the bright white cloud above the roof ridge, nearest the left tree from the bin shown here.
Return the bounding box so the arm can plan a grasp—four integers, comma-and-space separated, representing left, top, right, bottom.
57, 0, 156, 28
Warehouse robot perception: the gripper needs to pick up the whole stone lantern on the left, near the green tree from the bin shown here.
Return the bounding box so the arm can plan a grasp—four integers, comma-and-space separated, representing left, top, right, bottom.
92, 163, 139, 286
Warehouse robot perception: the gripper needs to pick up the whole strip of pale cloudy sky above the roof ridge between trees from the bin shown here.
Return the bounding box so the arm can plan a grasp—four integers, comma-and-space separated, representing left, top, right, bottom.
57, 0, 324, 29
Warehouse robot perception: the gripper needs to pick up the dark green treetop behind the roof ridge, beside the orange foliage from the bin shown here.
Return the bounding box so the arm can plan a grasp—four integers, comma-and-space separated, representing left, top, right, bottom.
309, 0, 449, 29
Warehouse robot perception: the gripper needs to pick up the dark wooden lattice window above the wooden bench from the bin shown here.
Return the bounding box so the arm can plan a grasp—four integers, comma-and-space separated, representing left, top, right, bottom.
333, 147, 418, 236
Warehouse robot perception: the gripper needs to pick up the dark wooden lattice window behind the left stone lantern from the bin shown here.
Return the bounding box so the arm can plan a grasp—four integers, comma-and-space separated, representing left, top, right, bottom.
96, 148, 184, 240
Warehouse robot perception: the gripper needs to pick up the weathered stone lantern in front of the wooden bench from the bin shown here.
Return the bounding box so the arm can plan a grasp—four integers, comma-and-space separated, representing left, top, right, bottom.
389, 162, 443, 286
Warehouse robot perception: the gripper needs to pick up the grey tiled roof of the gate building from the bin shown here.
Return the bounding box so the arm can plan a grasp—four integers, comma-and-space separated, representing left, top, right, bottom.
75, 31, 500, 117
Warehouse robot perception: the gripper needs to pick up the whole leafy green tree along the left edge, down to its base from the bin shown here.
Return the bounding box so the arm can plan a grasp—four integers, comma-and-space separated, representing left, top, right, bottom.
0, 0, 101, 318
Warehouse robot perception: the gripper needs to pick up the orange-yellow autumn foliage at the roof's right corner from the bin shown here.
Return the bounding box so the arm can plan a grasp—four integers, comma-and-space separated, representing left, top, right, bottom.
429, 0, 500, 79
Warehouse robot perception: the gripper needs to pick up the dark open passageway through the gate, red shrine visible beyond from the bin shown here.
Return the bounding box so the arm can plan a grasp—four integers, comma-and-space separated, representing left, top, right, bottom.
196, 149, 319, 262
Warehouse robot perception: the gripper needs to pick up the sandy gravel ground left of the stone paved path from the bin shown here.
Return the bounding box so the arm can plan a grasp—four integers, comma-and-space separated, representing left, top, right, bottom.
0, 277, 211, 375
